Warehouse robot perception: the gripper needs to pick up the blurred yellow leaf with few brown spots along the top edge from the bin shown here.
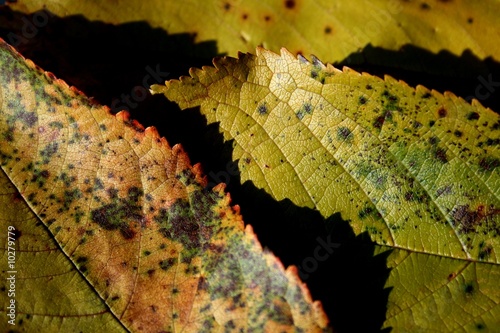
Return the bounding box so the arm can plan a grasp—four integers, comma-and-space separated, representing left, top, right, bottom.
10, 0, 500, 61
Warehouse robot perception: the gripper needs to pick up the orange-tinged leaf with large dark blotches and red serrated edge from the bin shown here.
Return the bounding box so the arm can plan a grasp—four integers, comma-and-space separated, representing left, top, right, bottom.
0, 41, 328, 332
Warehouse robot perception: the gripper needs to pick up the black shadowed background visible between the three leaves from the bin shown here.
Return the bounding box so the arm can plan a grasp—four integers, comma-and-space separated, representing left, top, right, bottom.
0, 7, 500, 332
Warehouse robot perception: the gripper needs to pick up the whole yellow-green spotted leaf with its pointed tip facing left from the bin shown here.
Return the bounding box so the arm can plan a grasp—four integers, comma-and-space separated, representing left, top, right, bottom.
156, 48, 500, 331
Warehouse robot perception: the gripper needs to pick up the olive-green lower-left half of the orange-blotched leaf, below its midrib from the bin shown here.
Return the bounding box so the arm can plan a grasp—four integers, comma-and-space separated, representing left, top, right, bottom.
0, 170, 126, 333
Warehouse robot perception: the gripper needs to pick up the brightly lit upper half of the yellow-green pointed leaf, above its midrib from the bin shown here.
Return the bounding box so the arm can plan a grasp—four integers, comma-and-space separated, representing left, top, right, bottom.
157, 49, 500, 263
